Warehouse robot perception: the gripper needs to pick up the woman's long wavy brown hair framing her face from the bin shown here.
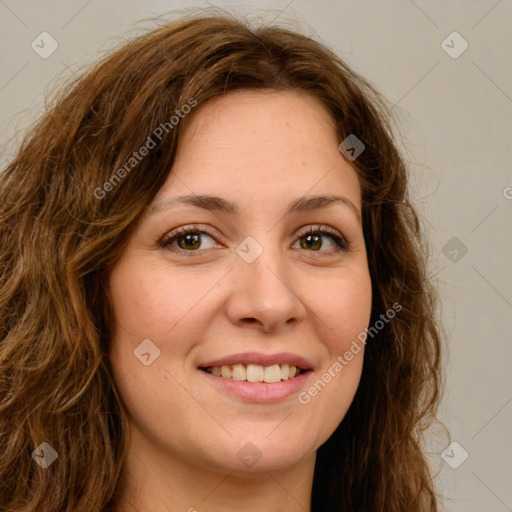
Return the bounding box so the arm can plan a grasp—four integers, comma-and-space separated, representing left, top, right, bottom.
0, 12, 442, 512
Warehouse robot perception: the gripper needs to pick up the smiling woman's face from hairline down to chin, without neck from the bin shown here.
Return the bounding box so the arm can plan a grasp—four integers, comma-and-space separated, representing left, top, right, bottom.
109, 91, 371, 472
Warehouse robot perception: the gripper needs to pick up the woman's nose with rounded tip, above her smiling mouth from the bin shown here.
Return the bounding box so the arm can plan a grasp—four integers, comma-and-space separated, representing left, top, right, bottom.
227, 239, 306, 332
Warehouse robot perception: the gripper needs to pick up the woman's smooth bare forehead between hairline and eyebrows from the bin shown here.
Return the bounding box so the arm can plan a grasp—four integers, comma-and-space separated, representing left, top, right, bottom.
152, 90, 360, 202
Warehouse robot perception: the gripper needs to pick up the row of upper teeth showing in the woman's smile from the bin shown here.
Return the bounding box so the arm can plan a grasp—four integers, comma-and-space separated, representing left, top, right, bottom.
206, 364, 300, 383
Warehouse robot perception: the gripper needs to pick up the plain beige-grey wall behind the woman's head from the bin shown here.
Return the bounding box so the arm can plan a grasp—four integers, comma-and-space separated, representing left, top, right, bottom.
0, 0, 512, 512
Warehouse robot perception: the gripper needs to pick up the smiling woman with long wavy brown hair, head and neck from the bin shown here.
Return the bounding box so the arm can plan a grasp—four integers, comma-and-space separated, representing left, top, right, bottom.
0, 9, 441, 512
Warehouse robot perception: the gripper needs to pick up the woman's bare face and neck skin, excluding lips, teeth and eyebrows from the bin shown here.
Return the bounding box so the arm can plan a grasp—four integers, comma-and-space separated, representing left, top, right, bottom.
108, 91, 372, 512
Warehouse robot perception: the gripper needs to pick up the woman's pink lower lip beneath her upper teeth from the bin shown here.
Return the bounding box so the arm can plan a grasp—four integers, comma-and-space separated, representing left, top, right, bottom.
198, 370, 313, 403
